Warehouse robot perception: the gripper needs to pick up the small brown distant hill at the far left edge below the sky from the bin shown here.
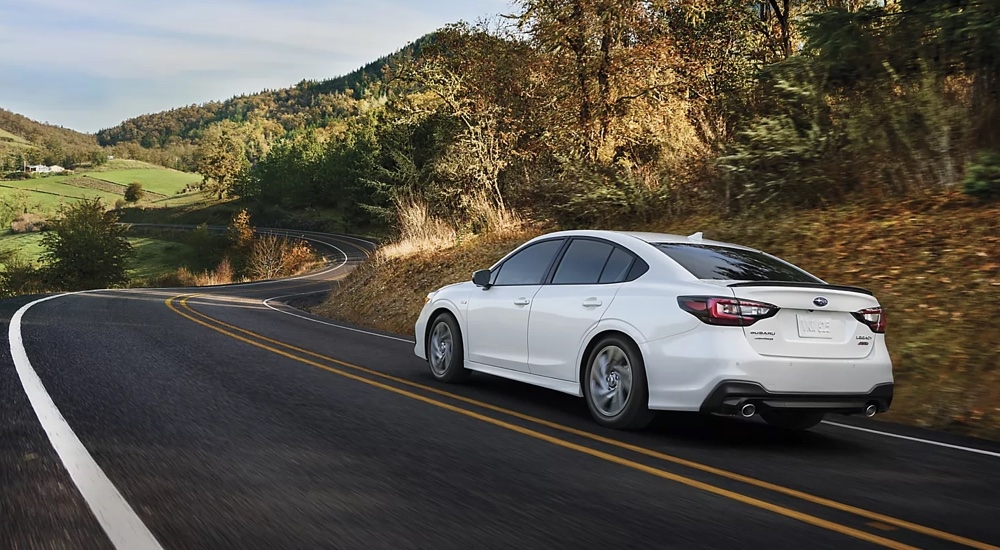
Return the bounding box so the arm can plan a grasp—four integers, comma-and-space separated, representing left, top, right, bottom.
0, 109, 105, 172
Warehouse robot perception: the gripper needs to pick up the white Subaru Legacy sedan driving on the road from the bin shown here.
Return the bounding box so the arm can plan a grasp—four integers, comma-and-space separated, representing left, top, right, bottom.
414, 231, 893, 430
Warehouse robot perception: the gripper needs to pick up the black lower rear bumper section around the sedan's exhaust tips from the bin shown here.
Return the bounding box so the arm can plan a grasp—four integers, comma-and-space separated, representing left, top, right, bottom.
701, 380, 894, 415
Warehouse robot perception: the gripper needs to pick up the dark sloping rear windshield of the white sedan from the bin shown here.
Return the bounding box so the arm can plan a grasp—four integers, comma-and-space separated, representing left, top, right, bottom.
653, 243, 821, 283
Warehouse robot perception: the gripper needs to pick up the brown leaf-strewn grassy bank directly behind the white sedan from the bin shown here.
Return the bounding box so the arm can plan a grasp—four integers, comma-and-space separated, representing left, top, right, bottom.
316, 192, 1000, 439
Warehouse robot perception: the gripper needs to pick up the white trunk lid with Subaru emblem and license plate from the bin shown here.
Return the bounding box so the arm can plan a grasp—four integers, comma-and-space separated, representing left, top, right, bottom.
728, 281, 879, 359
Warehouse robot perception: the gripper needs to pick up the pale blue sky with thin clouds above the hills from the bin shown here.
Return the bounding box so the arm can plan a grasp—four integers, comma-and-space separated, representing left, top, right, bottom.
0, 0, 514, 132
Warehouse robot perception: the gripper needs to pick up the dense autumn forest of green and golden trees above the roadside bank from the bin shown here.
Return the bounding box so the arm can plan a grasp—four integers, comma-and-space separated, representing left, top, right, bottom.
105, 0, 1000, 232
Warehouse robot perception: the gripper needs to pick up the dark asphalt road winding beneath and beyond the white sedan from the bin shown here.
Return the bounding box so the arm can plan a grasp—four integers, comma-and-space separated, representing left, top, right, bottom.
0, 234, 1000, 549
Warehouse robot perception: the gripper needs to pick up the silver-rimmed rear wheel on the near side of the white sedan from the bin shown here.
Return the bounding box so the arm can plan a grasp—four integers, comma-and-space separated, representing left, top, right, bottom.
581, 335, 655, 430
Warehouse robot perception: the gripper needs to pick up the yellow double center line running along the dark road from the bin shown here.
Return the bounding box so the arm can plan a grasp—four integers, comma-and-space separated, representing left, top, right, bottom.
165, 295, 1000, 550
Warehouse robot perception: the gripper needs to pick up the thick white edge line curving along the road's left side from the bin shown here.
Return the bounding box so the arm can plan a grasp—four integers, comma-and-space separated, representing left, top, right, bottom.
8, 291, 163, 550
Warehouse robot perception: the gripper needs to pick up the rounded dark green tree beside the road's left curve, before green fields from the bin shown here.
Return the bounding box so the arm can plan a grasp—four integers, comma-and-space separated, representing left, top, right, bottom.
41, 198, 135, 290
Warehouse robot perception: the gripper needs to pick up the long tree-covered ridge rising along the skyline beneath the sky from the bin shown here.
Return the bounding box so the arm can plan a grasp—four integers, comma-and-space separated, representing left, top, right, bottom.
97, 33, 434, 148
